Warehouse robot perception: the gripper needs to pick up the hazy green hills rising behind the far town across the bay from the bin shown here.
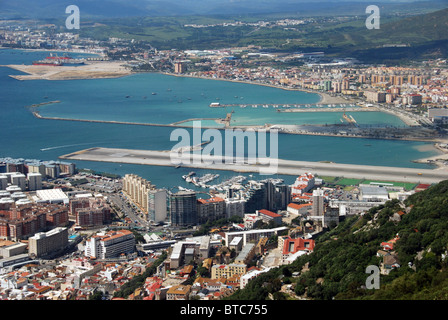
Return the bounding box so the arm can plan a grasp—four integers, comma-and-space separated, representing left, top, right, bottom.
71, 3, 448, 64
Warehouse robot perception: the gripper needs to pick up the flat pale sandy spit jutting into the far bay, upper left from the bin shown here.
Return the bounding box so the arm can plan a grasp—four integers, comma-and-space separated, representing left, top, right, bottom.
3, 61, 132, 80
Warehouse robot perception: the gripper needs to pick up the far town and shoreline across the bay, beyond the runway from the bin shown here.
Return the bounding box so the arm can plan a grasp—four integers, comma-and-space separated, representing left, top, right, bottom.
0, 20, 448, 146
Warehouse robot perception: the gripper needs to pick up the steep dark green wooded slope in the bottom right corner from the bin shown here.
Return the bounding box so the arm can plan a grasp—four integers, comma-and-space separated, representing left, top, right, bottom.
230, 181, 448, 300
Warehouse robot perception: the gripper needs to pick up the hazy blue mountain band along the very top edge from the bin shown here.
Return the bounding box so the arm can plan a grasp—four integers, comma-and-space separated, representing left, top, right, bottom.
0, 0, 448, 19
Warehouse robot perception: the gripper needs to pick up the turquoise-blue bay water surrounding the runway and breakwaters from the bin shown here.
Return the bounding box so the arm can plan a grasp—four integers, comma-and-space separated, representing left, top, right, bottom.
0, 49, 437, 187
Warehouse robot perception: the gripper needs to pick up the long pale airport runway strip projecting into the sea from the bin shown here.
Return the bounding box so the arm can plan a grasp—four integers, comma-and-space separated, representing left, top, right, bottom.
60, 148, 448, 183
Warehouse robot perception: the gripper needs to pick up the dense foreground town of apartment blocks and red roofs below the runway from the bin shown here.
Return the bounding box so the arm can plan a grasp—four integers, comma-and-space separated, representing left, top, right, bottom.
0, 158, 430, 300
